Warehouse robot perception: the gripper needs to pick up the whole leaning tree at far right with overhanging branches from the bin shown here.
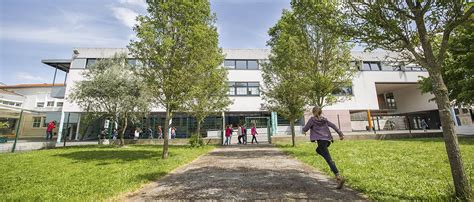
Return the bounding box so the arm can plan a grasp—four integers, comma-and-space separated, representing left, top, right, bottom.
341, 0, 474, 199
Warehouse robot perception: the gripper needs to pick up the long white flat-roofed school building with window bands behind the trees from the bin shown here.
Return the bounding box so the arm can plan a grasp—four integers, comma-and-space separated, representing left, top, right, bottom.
42, 48, 472, 142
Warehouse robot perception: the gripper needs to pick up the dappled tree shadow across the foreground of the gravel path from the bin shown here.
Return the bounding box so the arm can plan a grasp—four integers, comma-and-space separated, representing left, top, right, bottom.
129, 166, 366, 201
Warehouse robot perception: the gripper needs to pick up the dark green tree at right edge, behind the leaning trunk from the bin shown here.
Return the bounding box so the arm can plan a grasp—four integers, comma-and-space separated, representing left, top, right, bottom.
419, 22, 474, 106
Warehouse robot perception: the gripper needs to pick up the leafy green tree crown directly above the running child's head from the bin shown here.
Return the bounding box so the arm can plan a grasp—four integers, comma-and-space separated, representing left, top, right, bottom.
291, 0, 357, 108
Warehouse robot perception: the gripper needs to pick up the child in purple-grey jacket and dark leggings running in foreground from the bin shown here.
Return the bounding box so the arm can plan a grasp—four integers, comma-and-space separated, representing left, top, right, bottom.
303, 106, 345, 189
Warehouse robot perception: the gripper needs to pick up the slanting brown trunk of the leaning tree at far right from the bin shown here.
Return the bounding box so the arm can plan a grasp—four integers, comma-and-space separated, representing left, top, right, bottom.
430, 65, 471, 199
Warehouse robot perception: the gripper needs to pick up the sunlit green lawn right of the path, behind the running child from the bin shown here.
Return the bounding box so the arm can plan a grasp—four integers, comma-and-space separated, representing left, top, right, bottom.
279, 138, 474, 200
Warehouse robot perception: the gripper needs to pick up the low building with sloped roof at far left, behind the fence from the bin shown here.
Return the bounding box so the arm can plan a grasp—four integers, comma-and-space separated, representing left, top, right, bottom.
0, 84, 64, 139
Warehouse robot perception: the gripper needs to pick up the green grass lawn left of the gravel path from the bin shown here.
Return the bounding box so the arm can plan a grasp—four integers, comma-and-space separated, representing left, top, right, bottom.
0, 146, 214, 201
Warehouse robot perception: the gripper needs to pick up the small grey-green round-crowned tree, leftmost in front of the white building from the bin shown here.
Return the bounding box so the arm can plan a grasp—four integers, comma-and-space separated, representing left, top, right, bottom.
69, 54, 149, 145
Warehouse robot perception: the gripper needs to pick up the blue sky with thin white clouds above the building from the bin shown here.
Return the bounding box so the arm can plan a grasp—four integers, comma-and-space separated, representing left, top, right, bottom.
0, 0, 290, 85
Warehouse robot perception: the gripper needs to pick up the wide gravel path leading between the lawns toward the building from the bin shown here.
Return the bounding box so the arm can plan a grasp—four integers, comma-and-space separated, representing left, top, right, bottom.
125, 145, 365, 201
